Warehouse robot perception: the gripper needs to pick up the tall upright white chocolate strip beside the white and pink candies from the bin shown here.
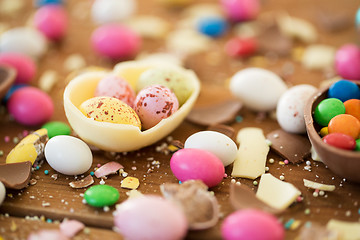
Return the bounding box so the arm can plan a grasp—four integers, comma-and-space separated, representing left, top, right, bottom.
231, 127, 269, 179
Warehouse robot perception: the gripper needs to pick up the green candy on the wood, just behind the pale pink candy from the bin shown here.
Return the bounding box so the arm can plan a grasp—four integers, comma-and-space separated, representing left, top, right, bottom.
84, 184, 120, 207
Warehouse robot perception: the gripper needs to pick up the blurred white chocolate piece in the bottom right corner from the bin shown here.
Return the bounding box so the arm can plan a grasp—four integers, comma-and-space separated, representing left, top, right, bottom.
326, 219, 360, 240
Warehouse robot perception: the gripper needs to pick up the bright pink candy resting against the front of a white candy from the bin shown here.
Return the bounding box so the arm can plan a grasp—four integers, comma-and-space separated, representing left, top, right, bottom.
170, 148, 225, 187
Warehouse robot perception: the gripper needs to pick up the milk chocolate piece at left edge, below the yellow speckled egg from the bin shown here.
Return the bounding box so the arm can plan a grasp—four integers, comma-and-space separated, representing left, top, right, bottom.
0, 161, 32, 189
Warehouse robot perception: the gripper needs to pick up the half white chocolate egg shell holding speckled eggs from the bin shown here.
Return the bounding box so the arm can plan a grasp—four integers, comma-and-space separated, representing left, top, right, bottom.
64, 61, 200, 152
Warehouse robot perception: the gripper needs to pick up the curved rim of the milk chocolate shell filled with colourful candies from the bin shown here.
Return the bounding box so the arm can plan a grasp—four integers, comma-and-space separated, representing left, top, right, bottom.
304, 82, 360, 158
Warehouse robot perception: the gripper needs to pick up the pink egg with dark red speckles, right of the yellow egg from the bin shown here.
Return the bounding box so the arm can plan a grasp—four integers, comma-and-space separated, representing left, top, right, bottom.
134, 85, 179, 129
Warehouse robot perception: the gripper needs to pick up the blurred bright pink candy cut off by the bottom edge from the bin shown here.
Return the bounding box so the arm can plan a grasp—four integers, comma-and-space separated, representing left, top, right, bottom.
221, 209, 285, 240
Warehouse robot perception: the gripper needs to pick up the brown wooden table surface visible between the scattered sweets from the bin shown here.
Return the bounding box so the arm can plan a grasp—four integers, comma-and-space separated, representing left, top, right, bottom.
0, 0, 360, 239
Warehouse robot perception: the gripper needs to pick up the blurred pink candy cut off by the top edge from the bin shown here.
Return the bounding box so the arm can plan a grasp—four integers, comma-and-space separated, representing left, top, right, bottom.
221, 0, 260, 22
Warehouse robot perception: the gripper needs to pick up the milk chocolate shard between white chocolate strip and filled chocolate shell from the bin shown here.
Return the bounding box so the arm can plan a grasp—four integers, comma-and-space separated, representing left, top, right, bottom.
266, 129, 311, 163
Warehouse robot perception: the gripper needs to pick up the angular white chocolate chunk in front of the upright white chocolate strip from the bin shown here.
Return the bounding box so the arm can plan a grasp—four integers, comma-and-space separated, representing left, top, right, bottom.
256, 173, 301, 210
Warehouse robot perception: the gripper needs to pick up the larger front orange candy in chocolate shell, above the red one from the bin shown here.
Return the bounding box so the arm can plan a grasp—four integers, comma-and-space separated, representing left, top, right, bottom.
328, 114, 360, 139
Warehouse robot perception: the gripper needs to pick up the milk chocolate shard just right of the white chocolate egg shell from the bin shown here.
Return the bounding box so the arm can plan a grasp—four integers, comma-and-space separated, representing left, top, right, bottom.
186, 99, 242, 126
